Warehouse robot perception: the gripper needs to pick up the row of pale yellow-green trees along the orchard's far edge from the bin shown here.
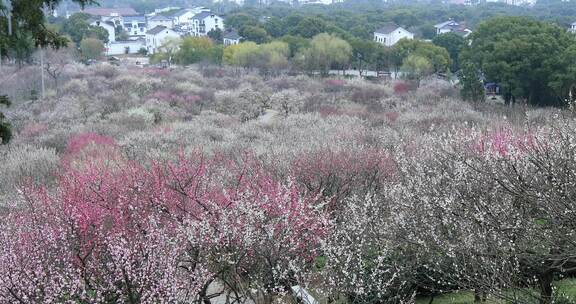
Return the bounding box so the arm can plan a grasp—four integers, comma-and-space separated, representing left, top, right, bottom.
153, 33, 452, 81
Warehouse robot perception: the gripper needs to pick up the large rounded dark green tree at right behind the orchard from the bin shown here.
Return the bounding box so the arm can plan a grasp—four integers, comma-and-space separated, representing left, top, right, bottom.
462, 17, 576, 105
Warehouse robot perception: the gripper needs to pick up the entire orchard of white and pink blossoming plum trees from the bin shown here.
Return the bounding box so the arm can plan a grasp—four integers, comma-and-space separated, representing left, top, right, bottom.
0, 66, 576, 304
